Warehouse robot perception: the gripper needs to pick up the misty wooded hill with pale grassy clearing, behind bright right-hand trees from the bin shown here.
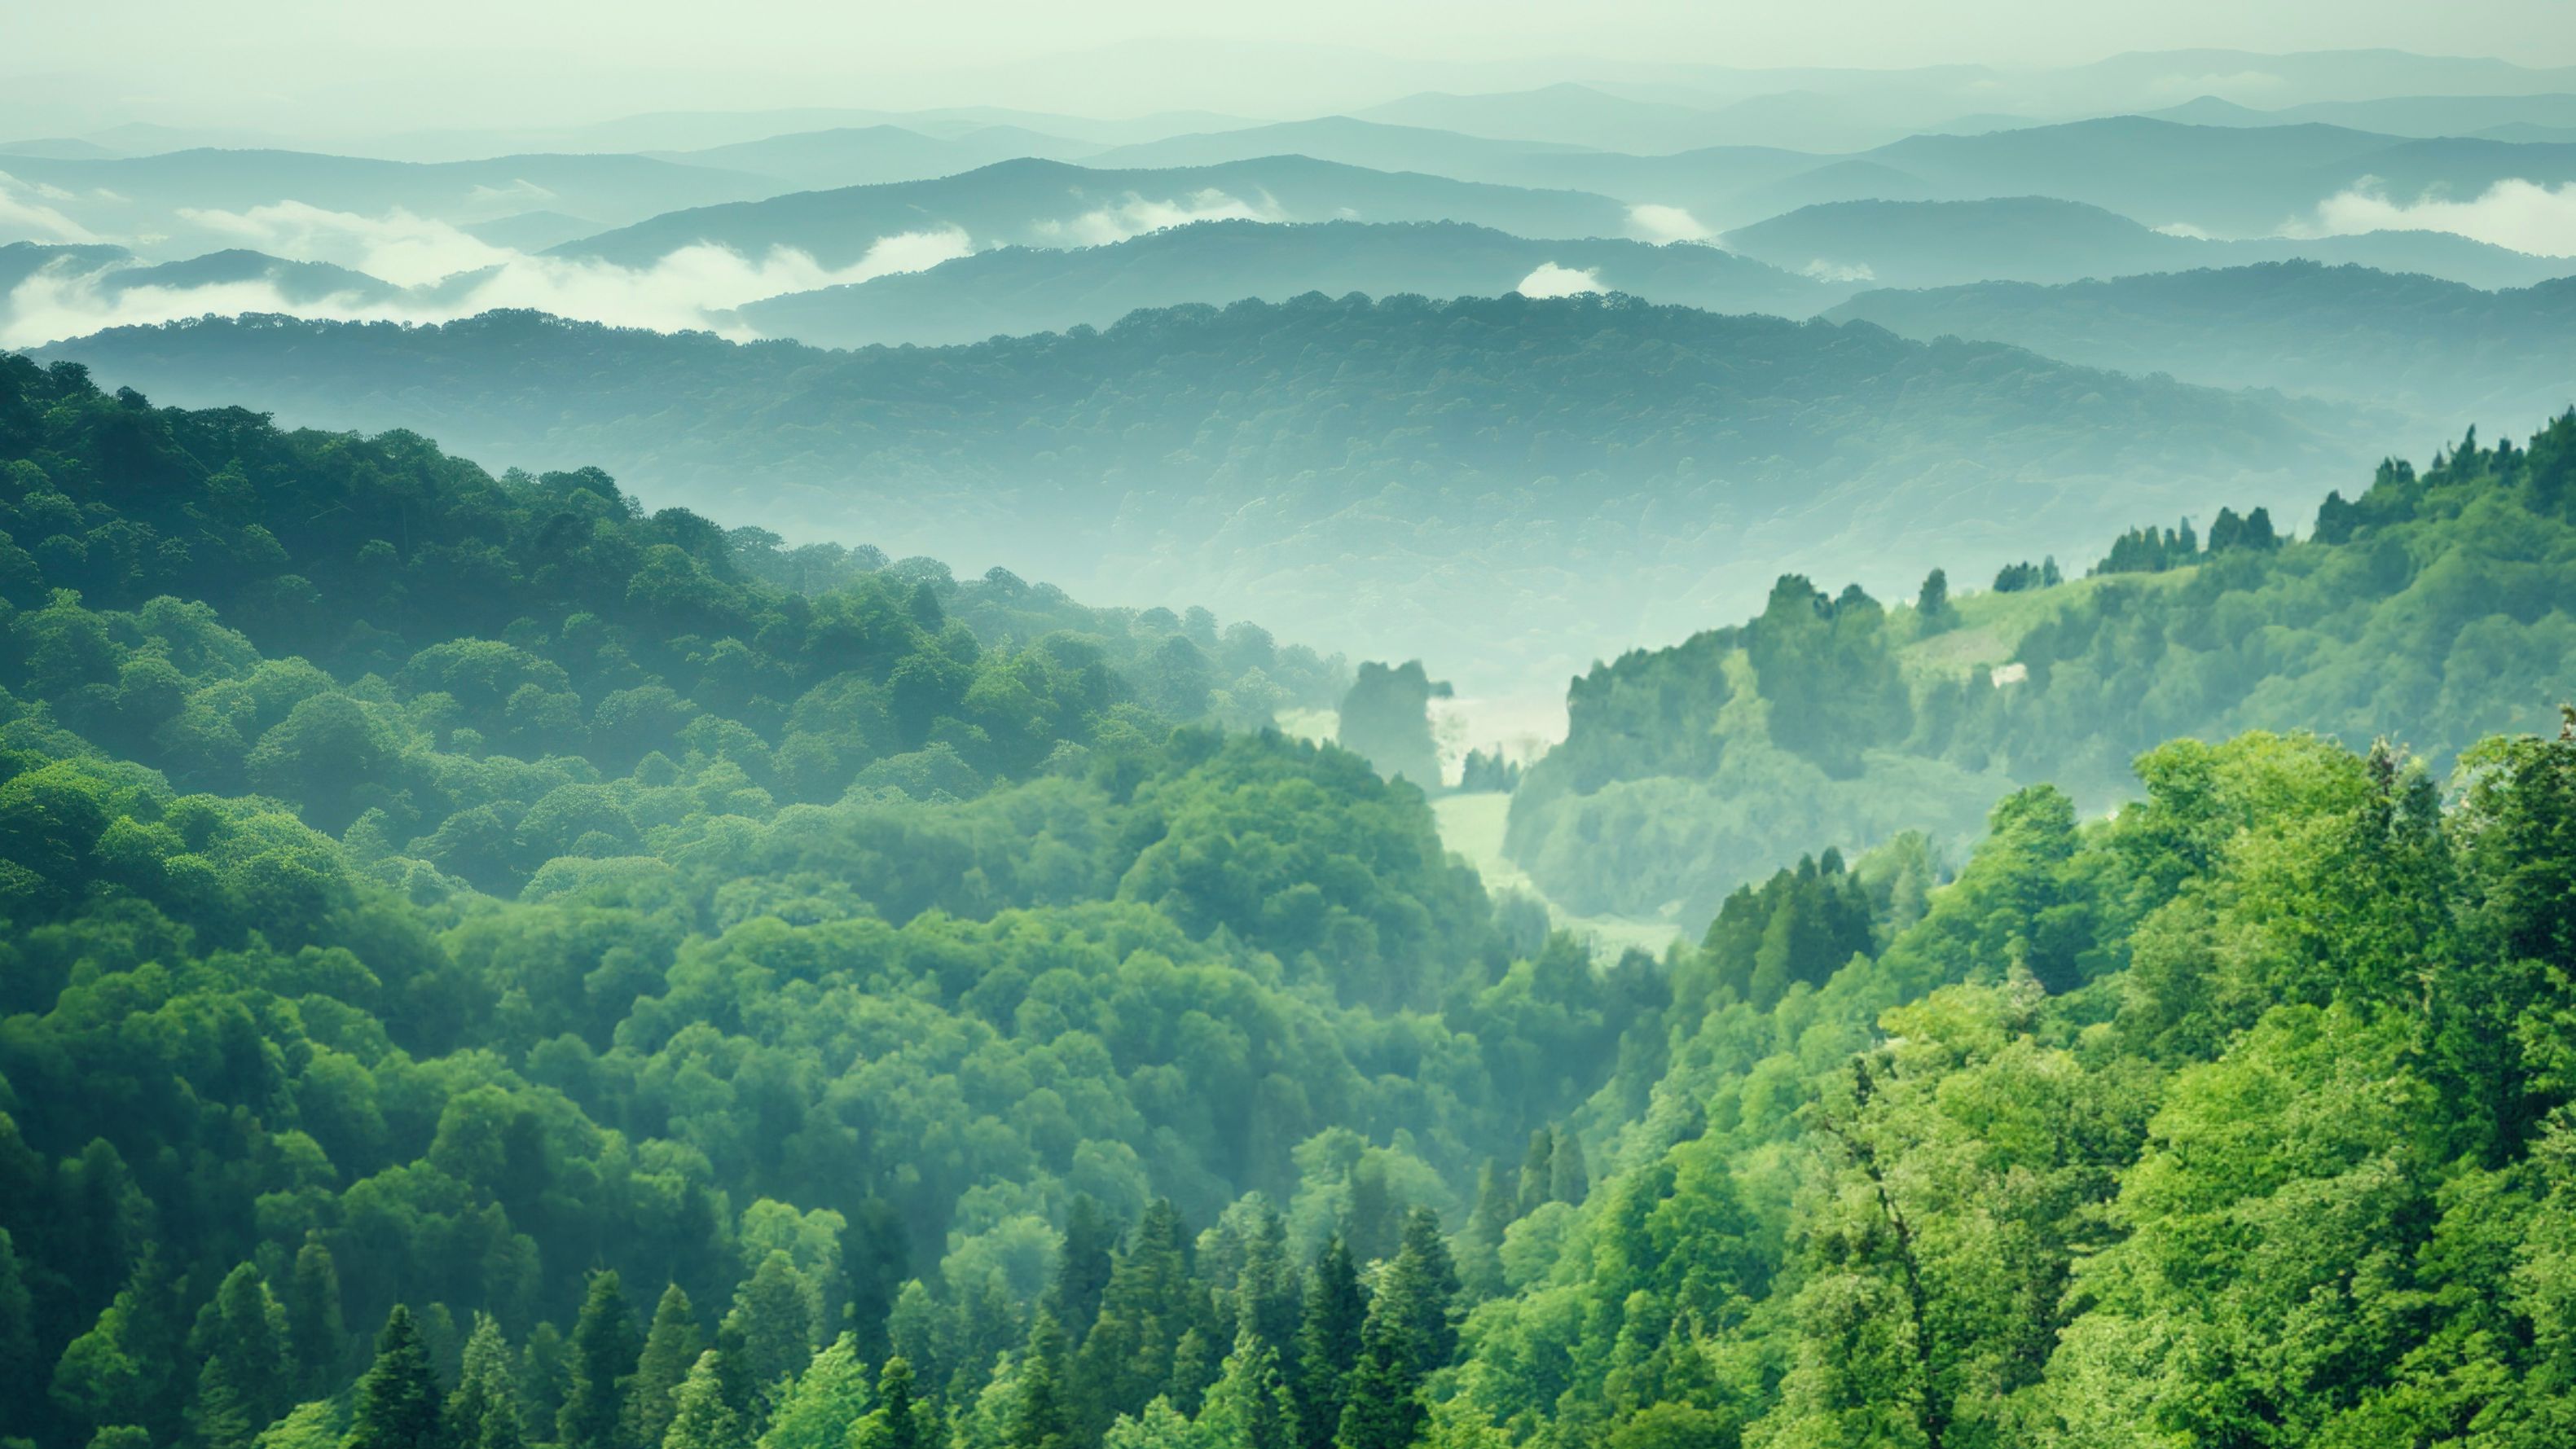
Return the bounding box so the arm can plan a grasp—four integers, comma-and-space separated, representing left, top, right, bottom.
1510, 415, 2576, 924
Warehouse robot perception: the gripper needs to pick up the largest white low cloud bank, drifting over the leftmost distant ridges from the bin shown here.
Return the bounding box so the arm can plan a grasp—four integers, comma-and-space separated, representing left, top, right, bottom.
0, 204, 974, 348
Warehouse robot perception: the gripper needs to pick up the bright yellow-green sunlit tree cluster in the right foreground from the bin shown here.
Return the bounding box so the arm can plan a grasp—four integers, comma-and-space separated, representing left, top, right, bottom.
1435, 731, 2576, 1449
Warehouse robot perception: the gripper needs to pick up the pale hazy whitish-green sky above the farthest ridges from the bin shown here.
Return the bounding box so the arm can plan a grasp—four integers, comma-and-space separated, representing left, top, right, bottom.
0, 0, 2576, 139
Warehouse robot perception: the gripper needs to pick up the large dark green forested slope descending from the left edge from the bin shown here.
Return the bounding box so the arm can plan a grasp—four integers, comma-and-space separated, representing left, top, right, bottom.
0, 358, 1661, 1449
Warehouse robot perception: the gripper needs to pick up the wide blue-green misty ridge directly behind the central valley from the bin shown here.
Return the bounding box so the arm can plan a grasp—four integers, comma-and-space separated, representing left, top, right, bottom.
49, 296, 2357, 687
